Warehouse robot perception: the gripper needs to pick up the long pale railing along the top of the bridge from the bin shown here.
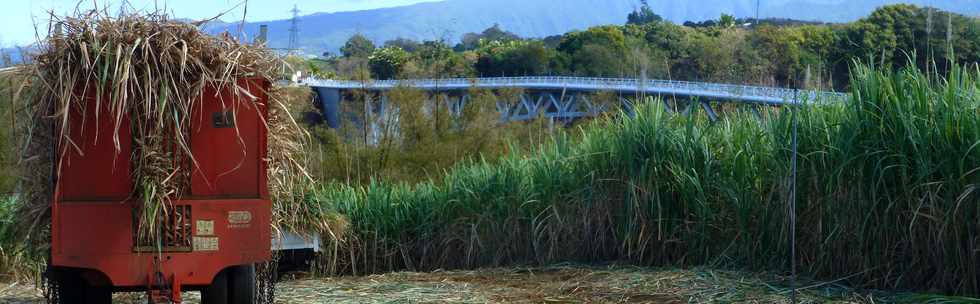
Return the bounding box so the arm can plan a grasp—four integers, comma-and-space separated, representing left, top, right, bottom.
300, 76, 847, 103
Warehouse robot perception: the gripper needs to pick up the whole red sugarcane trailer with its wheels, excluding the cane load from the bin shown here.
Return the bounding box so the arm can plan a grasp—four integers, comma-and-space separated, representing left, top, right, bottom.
49, 79, 271, 303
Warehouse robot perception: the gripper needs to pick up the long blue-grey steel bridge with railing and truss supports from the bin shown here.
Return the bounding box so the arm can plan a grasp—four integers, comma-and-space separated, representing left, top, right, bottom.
297, 77, 848, 128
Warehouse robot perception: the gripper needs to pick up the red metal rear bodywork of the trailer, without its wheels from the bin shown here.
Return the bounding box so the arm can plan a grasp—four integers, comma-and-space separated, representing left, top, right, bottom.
51, 80, 272, 288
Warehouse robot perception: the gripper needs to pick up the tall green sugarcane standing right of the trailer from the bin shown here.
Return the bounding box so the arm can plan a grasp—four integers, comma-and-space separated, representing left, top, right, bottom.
328, 66, 980, 294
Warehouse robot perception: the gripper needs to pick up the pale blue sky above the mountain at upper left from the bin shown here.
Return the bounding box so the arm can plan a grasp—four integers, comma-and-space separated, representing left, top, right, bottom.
0, 0, 444, 47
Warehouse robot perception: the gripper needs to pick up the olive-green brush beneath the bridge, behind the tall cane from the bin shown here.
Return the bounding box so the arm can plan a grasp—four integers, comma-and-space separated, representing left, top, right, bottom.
310, 87, 551, 185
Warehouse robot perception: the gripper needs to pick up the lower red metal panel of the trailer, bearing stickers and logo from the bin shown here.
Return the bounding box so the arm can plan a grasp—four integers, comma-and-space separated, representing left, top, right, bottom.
51, 199, 272, 287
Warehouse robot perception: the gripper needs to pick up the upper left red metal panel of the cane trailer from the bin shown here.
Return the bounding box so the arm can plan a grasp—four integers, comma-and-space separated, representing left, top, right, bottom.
59, 93, 132, 201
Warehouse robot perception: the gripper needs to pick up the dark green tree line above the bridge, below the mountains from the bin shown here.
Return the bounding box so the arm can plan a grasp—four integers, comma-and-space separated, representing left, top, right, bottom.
308, 4, 980, 89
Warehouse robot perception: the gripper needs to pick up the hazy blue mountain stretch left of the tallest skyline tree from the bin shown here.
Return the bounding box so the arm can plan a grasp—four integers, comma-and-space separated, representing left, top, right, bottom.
210, 0, 637, 54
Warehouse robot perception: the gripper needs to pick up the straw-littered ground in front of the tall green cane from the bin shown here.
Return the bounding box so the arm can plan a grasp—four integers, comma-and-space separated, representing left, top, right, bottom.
0, 266, 964, 304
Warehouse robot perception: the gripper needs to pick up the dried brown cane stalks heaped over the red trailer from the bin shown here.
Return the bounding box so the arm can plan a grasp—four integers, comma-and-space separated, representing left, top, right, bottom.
19, 11, 308, 254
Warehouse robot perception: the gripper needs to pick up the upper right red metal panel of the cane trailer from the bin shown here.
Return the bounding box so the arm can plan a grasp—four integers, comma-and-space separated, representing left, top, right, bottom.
191, 77, 266, 198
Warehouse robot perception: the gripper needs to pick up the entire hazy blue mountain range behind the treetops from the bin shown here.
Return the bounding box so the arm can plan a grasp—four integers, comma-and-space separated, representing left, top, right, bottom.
209, 0, 980, 54
